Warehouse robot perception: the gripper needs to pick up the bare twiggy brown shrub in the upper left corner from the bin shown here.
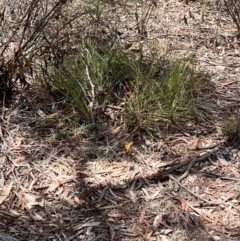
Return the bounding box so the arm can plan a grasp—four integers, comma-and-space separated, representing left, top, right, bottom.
0, 0, 73, 104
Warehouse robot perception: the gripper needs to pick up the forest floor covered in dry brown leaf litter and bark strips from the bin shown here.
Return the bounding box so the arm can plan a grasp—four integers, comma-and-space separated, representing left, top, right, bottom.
0, 0, 240, 241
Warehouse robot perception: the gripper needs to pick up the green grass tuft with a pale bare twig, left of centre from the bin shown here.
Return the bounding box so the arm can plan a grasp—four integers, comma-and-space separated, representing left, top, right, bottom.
50, 45, 107, 120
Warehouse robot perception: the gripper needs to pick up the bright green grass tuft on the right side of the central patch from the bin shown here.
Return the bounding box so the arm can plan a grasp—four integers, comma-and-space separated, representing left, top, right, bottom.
123, 56, 202, 130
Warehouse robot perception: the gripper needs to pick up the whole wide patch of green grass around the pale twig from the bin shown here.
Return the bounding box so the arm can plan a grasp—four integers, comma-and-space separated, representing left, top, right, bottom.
49, 43, 204, 131
